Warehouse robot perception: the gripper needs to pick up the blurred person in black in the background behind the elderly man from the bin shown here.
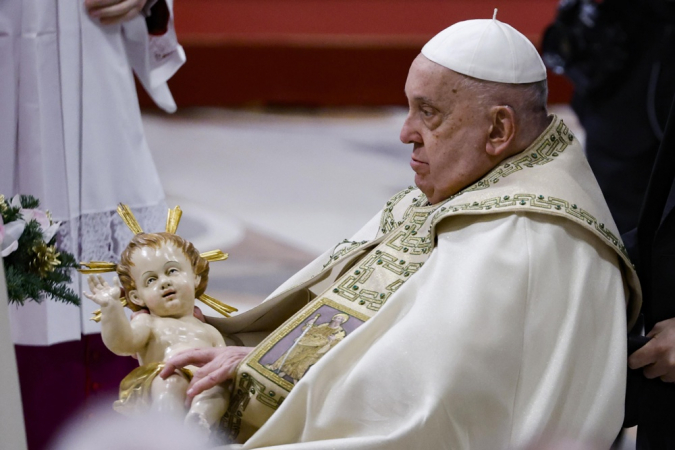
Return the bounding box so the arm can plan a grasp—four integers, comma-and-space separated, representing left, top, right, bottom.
543, 0, 675, 234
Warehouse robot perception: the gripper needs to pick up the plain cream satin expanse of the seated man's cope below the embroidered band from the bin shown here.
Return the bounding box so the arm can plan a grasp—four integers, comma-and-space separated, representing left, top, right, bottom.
235, 214, 626, 450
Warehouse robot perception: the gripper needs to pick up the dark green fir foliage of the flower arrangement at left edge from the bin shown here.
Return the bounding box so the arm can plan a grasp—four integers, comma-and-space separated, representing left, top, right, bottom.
0, 195, 80, 305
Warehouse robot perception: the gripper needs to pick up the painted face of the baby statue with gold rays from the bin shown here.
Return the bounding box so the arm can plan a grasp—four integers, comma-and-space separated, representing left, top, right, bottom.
129, 243, 200, 317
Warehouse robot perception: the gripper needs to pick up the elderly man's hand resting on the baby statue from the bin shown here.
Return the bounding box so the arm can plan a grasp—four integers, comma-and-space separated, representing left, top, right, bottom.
159, 347, 253, 406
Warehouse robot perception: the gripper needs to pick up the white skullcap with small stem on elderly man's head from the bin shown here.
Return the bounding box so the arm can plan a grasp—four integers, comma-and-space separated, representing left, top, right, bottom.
422, 10, 546, 84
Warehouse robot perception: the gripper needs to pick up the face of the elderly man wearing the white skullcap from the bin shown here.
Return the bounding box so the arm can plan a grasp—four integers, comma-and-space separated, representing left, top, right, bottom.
401, 55, 492, 204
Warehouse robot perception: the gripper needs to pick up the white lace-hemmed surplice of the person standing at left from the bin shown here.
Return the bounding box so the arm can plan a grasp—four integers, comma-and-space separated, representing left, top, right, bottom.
0, 0, 184, 345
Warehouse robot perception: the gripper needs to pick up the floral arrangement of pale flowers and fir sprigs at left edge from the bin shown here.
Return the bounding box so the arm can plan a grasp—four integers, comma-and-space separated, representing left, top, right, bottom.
0, 195, 80, 305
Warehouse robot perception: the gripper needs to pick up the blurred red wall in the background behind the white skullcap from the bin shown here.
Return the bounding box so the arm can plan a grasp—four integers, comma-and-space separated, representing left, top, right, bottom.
143, 0, 571, 107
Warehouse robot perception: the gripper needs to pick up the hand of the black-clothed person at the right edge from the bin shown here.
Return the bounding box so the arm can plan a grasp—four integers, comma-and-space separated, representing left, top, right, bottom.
628, 318, 675, 383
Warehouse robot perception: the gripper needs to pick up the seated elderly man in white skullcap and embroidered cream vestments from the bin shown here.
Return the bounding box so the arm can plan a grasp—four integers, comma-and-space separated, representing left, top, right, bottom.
163, 14, 639, 449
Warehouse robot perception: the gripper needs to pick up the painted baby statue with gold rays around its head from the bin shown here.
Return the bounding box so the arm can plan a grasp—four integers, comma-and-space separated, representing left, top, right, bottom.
83, 205, 234, 433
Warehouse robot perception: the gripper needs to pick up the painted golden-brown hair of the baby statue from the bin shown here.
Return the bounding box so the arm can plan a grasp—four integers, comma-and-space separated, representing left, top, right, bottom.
117, 232, 209, 298
